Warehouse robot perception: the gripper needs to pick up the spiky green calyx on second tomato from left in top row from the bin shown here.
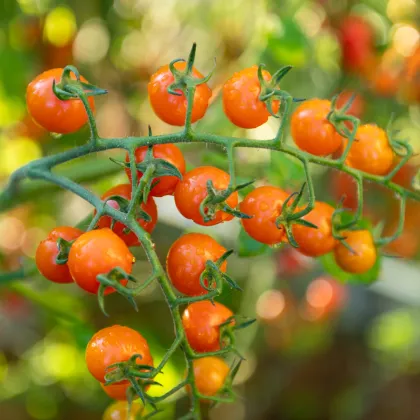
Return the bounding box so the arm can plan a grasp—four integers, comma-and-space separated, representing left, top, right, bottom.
168, 42, 216, 96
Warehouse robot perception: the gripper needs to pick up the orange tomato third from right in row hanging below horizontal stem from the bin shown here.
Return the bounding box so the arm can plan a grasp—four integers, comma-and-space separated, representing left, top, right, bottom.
240, 186, 288, 245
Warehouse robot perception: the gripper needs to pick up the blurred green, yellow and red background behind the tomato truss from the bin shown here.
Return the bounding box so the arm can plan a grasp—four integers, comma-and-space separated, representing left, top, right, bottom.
0, 0, 420, 420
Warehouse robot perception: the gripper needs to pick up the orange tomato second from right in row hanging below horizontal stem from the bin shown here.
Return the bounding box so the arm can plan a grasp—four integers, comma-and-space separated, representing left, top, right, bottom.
292, 201, 337, 257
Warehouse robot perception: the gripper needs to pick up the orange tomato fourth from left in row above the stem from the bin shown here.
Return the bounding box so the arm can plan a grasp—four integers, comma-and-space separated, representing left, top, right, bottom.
291, 99, 343, 156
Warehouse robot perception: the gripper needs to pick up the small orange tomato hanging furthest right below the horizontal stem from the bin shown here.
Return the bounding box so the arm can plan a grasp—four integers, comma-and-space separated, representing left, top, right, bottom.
334, 230, 376, 274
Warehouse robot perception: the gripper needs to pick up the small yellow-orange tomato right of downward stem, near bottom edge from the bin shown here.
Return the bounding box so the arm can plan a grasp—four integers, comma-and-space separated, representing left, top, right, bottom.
187, 356, 230, 397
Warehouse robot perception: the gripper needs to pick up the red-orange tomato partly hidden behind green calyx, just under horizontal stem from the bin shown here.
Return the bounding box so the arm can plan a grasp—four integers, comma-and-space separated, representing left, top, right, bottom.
125, 144, 185, 197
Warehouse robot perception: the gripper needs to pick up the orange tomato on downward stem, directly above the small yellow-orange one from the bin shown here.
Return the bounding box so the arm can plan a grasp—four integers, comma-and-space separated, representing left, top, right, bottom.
182, 300, 233, 353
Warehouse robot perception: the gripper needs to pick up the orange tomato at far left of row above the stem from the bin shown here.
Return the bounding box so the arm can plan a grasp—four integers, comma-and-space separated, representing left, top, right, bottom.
26, 68, 95, 134
